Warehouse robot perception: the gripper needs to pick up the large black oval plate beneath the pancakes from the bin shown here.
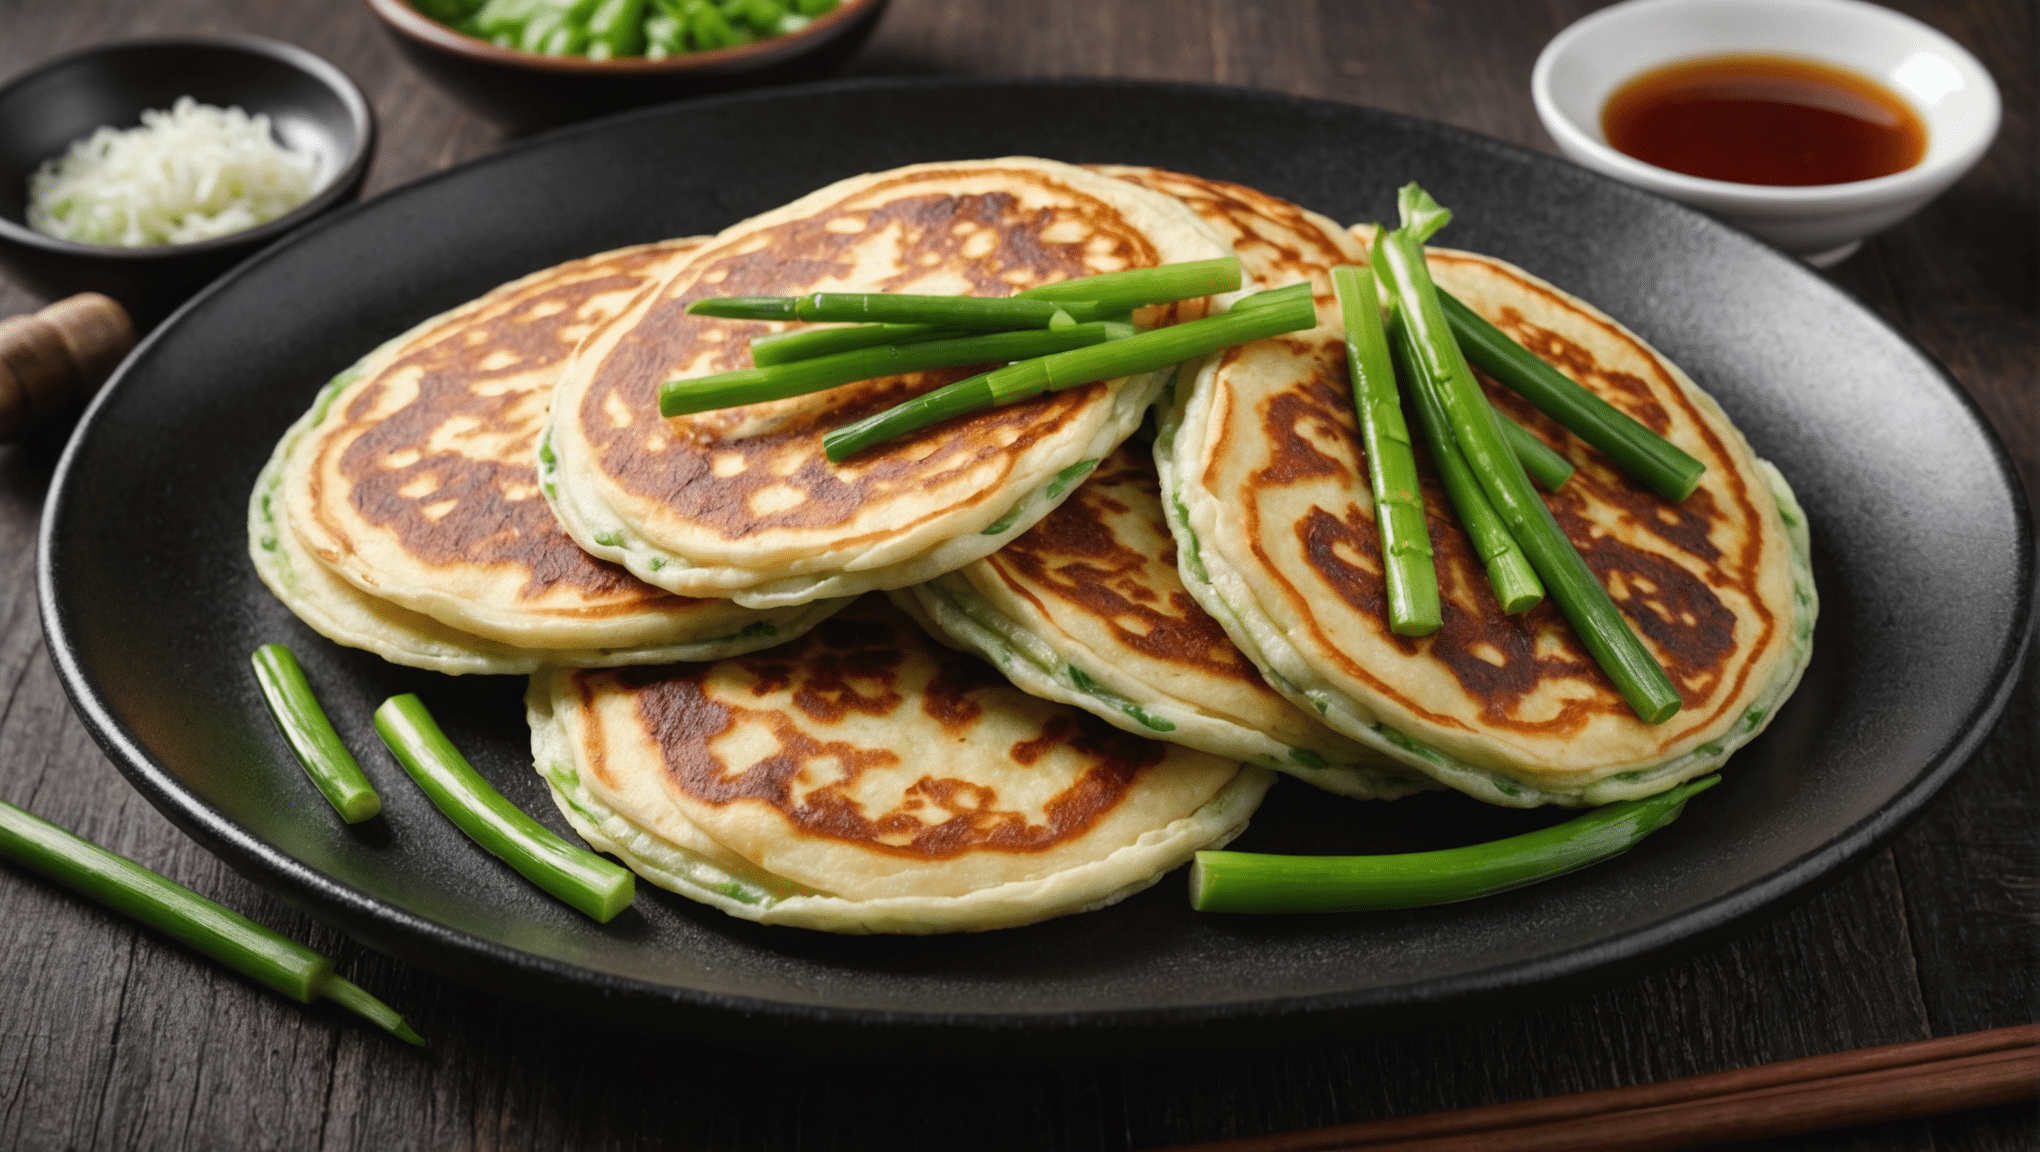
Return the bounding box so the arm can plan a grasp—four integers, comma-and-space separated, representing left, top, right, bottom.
41, 80, 2032, 1058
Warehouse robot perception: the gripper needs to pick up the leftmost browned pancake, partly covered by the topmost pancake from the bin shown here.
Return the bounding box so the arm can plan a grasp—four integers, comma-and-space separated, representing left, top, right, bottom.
249, 239, 845, 673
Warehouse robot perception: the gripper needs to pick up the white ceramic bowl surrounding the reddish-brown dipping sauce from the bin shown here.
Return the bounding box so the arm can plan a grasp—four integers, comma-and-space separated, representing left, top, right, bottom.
1530, 0, 2001, 208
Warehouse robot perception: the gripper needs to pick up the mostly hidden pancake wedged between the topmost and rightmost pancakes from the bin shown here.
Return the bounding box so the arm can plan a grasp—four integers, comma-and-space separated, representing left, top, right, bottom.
891, 444, 1436, 799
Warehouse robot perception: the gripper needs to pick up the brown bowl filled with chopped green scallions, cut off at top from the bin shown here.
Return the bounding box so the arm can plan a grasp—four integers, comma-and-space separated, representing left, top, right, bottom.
367, 0, 885, 130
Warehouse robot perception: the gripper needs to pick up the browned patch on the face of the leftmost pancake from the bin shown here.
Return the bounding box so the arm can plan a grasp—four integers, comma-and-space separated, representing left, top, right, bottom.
326, 251, 690, 612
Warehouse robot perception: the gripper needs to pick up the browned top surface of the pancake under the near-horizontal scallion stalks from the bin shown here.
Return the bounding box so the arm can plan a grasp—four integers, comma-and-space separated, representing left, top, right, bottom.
577, 171, 1167, 540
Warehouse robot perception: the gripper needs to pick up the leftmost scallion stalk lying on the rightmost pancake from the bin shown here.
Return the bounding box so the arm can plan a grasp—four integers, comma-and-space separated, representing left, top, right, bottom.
1332, 265, 1442, 636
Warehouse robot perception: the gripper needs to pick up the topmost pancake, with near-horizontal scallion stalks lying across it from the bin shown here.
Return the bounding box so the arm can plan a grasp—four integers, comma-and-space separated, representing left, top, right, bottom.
549, 157, 1228, 608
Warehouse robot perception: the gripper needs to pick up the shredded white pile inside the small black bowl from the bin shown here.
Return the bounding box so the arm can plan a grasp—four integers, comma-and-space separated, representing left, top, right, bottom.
29, 96, 316, 249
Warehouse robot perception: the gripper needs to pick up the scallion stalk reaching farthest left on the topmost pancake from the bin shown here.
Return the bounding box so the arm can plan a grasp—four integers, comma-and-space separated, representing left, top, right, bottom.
659, 322, 1134, 416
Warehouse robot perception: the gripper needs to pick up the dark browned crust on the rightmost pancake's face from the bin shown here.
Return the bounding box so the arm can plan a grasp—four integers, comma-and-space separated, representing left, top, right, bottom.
1206, 253, 1777, 736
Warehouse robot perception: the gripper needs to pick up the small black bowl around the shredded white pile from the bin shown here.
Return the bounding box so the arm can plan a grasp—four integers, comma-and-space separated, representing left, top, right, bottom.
0, 37, 375, 328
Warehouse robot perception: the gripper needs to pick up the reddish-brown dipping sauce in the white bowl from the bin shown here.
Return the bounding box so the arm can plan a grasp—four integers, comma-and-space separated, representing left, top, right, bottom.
1601, 55, 1926, 186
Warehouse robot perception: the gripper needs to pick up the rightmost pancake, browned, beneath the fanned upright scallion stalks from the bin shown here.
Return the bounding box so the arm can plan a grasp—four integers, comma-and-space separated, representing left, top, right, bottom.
1157, 196, 1816, 805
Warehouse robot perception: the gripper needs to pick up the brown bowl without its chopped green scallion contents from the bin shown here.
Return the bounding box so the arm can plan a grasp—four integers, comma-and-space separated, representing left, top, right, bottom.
367, 0, 885, 133
